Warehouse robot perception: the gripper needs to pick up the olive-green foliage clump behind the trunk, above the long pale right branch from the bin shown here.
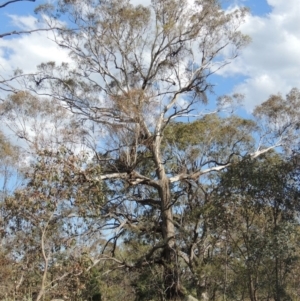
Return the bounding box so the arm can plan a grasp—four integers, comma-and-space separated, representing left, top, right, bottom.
163, 114, 256, 168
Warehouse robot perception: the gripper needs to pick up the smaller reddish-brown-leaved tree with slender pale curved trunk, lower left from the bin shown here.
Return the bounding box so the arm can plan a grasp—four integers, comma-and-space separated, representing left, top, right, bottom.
4, 148, 102, 301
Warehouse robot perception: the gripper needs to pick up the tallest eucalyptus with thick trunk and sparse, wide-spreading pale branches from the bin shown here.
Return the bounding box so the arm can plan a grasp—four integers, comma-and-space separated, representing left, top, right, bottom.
20, 0, 299, 299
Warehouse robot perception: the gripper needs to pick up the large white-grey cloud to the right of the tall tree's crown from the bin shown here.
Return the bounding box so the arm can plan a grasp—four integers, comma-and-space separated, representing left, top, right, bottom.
220, 0, 300, 110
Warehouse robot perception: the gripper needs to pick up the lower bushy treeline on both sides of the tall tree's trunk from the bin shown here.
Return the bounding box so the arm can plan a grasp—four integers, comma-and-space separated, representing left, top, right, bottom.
0, 117, 300, 301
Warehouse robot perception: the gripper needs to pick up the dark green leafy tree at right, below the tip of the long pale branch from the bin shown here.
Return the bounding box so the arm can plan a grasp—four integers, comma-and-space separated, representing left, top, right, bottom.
216, 153, 299, 301
